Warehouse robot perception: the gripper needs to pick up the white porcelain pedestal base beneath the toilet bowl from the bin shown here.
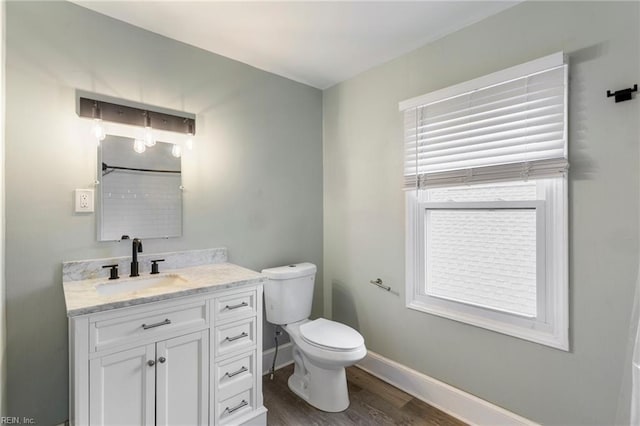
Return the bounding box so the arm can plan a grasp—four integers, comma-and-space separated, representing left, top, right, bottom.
287, 347, 349, 413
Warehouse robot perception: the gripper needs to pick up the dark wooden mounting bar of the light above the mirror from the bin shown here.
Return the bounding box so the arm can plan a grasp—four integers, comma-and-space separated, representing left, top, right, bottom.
78, 97, 196, 135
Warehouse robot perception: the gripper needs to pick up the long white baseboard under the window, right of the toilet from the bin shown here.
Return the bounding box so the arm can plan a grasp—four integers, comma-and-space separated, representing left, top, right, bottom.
356, 351, 537, 426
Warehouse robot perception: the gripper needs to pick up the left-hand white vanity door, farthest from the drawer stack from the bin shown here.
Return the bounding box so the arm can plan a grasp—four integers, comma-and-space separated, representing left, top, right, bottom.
89, 344, 155, 426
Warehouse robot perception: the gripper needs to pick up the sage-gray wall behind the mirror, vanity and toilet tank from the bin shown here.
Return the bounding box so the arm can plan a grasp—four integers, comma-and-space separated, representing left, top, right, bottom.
6, 2, 322, 425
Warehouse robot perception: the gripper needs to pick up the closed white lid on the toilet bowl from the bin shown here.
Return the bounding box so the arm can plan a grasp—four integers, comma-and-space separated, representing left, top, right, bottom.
300, 318, 364, 350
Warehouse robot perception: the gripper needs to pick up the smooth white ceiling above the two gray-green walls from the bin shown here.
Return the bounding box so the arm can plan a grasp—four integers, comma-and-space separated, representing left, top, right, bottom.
71, 0, 522, 89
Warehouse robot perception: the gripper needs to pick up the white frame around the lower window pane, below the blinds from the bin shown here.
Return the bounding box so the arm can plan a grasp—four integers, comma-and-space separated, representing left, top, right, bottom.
406, 177, 569, 351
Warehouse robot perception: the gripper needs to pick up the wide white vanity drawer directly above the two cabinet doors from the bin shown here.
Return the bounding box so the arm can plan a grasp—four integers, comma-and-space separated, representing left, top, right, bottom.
90, 300, 209, 351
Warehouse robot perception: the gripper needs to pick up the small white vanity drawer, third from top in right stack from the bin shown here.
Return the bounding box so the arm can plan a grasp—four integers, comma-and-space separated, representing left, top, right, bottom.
215, 351, 256, 400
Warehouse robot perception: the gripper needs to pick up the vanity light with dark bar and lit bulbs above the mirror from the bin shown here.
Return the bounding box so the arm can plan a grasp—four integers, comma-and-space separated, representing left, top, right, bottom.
76, 94, 196, 157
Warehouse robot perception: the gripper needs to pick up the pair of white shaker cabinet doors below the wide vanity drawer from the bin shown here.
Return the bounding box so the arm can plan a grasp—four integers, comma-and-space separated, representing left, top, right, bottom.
89, 331, 209, 426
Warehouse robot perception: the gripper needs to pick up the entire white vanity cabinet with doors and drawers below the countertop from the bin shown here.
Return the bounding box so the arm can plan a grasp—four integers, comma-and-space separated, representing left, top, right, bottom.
69, 284, 266, 426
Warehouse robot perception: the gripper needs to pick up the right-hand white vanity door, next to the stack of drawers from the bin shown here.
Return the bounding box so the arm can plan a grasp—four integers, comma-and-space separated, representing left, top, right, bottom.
156, 330, 209, 426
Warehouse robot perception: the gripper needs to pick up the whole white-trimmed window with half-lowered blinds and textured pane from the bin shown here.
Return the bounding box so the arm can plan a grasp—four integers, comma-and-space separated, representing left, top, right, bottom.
401, 54, 568, 350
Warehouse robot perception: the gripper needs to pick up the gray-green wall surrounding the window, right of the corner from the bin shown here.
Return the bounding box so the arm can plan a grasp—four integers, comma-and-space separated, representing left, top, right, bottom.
323, 2, 640, 425
